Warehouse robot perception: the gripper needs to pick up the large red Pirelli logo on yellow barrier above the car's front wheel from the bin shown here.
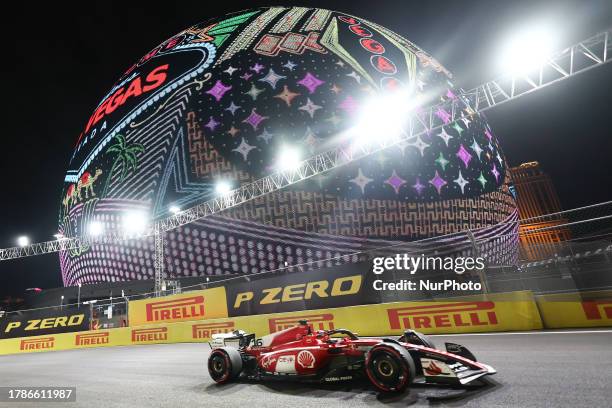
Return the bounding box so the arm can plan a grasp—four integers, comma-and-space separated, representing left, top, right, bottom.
387, 302, 497, 330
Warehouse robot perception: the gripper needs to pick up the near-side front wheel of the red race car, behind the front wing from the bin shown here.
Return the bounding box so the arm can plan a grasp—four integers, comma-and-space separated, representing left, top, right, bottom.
365, 343, 415, 392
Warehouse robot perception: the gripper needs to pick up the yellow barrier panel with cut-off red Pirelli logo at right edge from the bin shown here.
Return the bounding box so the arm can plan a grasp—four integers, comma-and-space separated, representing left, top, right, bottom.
536, 291, 612, 329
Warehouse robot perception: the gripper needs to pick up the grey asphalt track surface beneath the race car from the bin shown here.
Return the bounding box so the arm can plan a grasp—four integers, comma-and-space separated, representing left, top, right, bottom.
0, 330, 612, 408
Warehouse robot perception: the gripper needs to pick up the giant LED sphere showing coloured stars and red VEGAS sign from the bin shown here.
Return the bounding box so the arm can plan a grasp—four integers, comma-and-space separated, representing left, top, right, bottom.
59, 7, 517, 285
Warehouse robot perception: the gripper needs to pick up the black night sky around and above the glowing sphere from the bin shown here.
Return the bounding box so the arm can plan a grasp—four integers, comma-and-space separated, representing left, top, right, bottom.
0, 0, 612, 297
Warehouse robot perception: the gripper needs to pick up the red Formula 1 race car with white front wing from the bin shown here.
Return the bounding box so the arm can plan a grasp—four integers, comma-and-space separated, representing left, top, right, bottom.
208, 321, 496, 392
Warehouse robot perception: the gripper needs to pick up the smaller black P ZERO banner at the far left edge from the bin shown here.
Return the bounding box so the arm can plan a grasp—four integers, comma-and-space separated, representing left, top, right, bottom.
0, 307, 89, 338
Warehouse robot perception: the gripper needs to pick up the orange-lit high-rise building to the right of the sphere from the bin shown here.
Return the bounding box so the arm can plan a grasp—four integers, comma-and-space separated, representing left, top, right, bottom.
510, 161, 570, 261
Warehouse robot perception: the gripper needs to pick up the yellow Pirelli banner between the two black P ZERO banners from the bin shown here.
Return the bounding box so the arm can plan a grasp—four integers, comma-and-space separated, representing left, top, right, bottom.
129, 287, 227, 326
